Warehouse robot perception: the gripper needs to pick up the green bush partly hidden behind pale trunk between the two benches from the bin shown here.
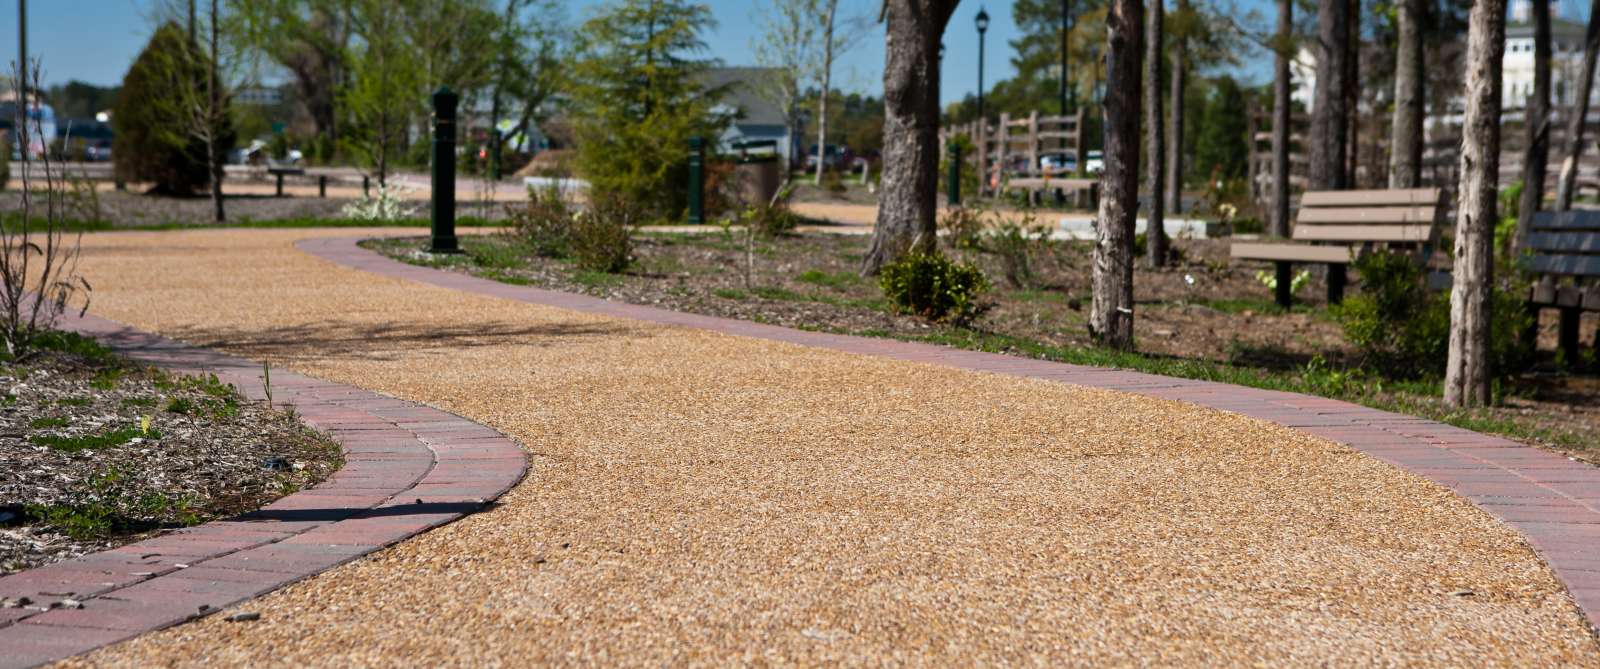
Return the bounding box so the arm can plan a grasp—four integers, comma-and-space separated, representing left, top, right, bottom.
1336, 251, 1530, 378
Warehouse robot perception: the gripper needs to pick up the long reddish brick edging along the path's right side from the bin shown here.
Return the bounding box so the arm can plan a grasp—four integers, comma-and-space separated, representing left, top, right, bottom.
296, 237, 1600, 629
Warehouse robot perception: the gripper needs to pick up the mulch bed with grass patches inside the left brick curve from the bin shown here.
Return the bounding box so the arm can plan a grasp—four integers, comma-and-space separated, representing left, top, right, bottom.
0, 335, 342, 575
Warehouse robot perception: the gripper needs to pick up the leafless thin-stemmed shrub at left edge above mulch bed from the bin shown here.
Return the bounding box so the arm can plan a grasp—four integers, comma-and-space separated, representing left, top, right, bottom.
0, 61, 91, 360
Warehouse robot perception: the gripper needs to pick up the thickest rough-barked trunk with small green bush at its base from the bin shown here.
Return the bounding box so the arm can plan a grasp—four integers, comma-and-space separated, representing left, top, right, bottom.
861, 0, 947, 275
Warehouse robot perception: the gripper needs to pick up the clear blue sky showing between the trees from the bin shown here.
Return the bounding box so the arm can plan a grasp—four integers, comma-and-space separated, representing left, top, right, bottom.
0, 0, 1344, 101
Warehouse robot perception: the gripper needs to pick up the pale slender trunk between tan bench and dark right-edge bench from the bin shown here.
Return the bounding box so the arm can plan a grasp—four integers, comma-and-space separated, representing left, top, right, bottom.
1445, 0, 1506, 407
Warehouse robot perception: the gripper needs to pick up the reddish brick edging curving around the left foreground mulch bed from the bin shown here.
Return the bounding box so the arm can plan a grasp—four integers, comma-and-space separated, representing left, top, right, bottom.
0, 315, 526, 669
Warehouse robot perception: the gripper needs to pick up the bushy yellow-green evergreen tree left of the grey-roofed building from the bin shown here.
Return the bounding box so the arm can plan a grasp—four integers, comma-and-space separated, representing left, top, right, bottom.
573, 0, 726, 218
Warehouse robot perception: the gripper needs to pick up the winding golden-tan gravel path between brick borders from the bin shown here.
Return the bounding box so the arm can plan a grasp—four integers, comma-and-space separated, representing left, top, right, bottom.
50, 230, 1600, 666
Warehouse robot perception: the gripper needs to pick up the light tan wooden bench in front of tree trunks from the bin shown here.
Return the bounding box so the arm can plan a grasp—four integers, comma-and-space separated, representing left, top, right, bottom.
1230, 189, 1446, 307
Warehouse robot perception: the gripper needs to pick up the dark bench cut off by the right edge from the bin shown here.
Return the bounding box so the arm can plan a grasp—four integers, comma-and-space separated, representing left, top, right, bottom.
1528, 211, 1600, 362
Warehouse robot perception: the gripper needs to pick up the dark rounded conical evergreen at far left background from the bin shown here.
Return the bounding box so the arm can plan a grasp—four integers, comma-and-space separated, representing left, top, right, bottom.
112, 22, 230, 195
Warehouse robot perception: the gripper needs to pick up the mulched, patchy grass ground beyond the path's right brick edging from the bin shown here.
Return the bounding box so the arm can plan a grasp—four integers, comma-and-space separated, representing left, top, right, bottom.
368, 232, 1600, 459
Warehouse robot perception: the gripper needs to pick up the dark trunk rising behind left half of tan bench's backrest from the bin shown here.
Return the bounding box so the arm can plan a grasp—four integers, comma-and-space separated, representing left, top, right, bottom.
1309, 0, 1350, 190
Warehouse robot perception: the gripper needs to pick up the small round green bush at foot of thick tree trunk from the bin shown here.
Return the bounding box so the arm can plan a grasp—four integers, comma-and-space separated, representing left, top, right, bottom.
878, 253, 989, 323
